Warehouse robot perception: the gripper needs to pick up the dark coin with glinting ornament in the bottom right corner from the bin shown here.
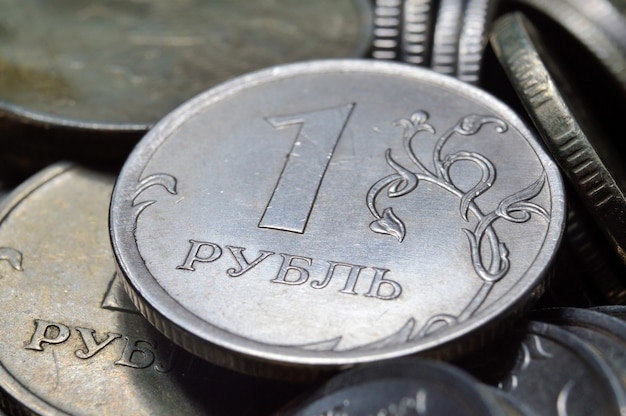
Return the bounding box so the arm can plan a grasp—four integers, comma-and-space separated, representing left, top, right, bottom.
492, 322, 626, 416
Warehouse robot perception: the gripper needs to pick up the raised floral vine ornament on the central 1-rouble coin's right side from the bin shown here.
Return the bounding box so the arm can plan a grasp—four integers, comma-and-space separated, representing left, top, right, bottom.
366, 111, 550, 340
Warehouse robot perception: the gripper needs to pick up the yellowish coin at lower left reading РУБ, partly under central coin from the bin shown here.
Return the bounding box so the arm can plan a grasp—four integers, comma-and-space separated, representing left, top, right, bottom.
0, 165, 297, 416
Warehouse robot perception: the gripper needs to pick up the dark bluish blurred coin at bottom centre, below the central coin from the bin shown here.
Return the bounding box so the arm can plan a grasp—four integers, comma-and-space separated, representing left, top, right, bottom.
279, 360, 504, 416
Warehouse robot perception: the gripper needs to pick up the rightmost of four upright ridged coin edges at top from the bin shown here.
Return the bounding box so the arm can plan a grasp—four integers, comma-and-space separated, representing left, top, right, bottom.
456, 0, 498, 84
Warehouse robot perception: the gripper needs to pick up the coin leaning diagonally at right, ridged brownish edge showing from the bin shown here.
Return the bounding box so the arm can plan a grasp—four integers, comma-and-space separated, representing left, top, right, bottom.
491, 13, 626, 270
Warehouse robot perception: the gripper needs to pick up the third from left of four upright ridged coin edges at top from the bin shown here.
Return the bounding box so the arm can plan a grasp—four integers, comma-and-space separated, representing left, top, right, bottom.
430, 0, 467, 76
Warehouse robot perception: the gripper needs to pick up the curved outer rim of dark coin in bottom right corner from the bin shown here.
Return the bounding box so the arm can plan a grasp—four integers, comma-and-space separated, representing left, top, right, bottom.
526, 321, 626, 414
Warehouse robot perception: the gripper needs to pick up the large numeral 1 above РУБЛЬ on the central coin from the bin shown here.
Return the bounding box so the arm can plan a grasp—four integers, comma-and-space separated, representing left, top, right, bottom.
259, 103, 354, 234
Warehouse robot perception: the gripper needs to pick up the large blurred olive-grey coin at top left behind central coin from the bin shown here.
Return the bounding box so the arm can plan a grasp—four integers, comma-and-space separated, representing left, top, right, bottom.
0, 0, 372, 131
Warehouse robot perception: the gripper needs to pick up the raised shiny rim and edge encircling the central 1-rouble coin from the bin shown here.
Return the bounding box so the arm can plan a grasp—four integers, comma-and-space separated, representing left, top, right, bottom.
109, 60, 565, 378
